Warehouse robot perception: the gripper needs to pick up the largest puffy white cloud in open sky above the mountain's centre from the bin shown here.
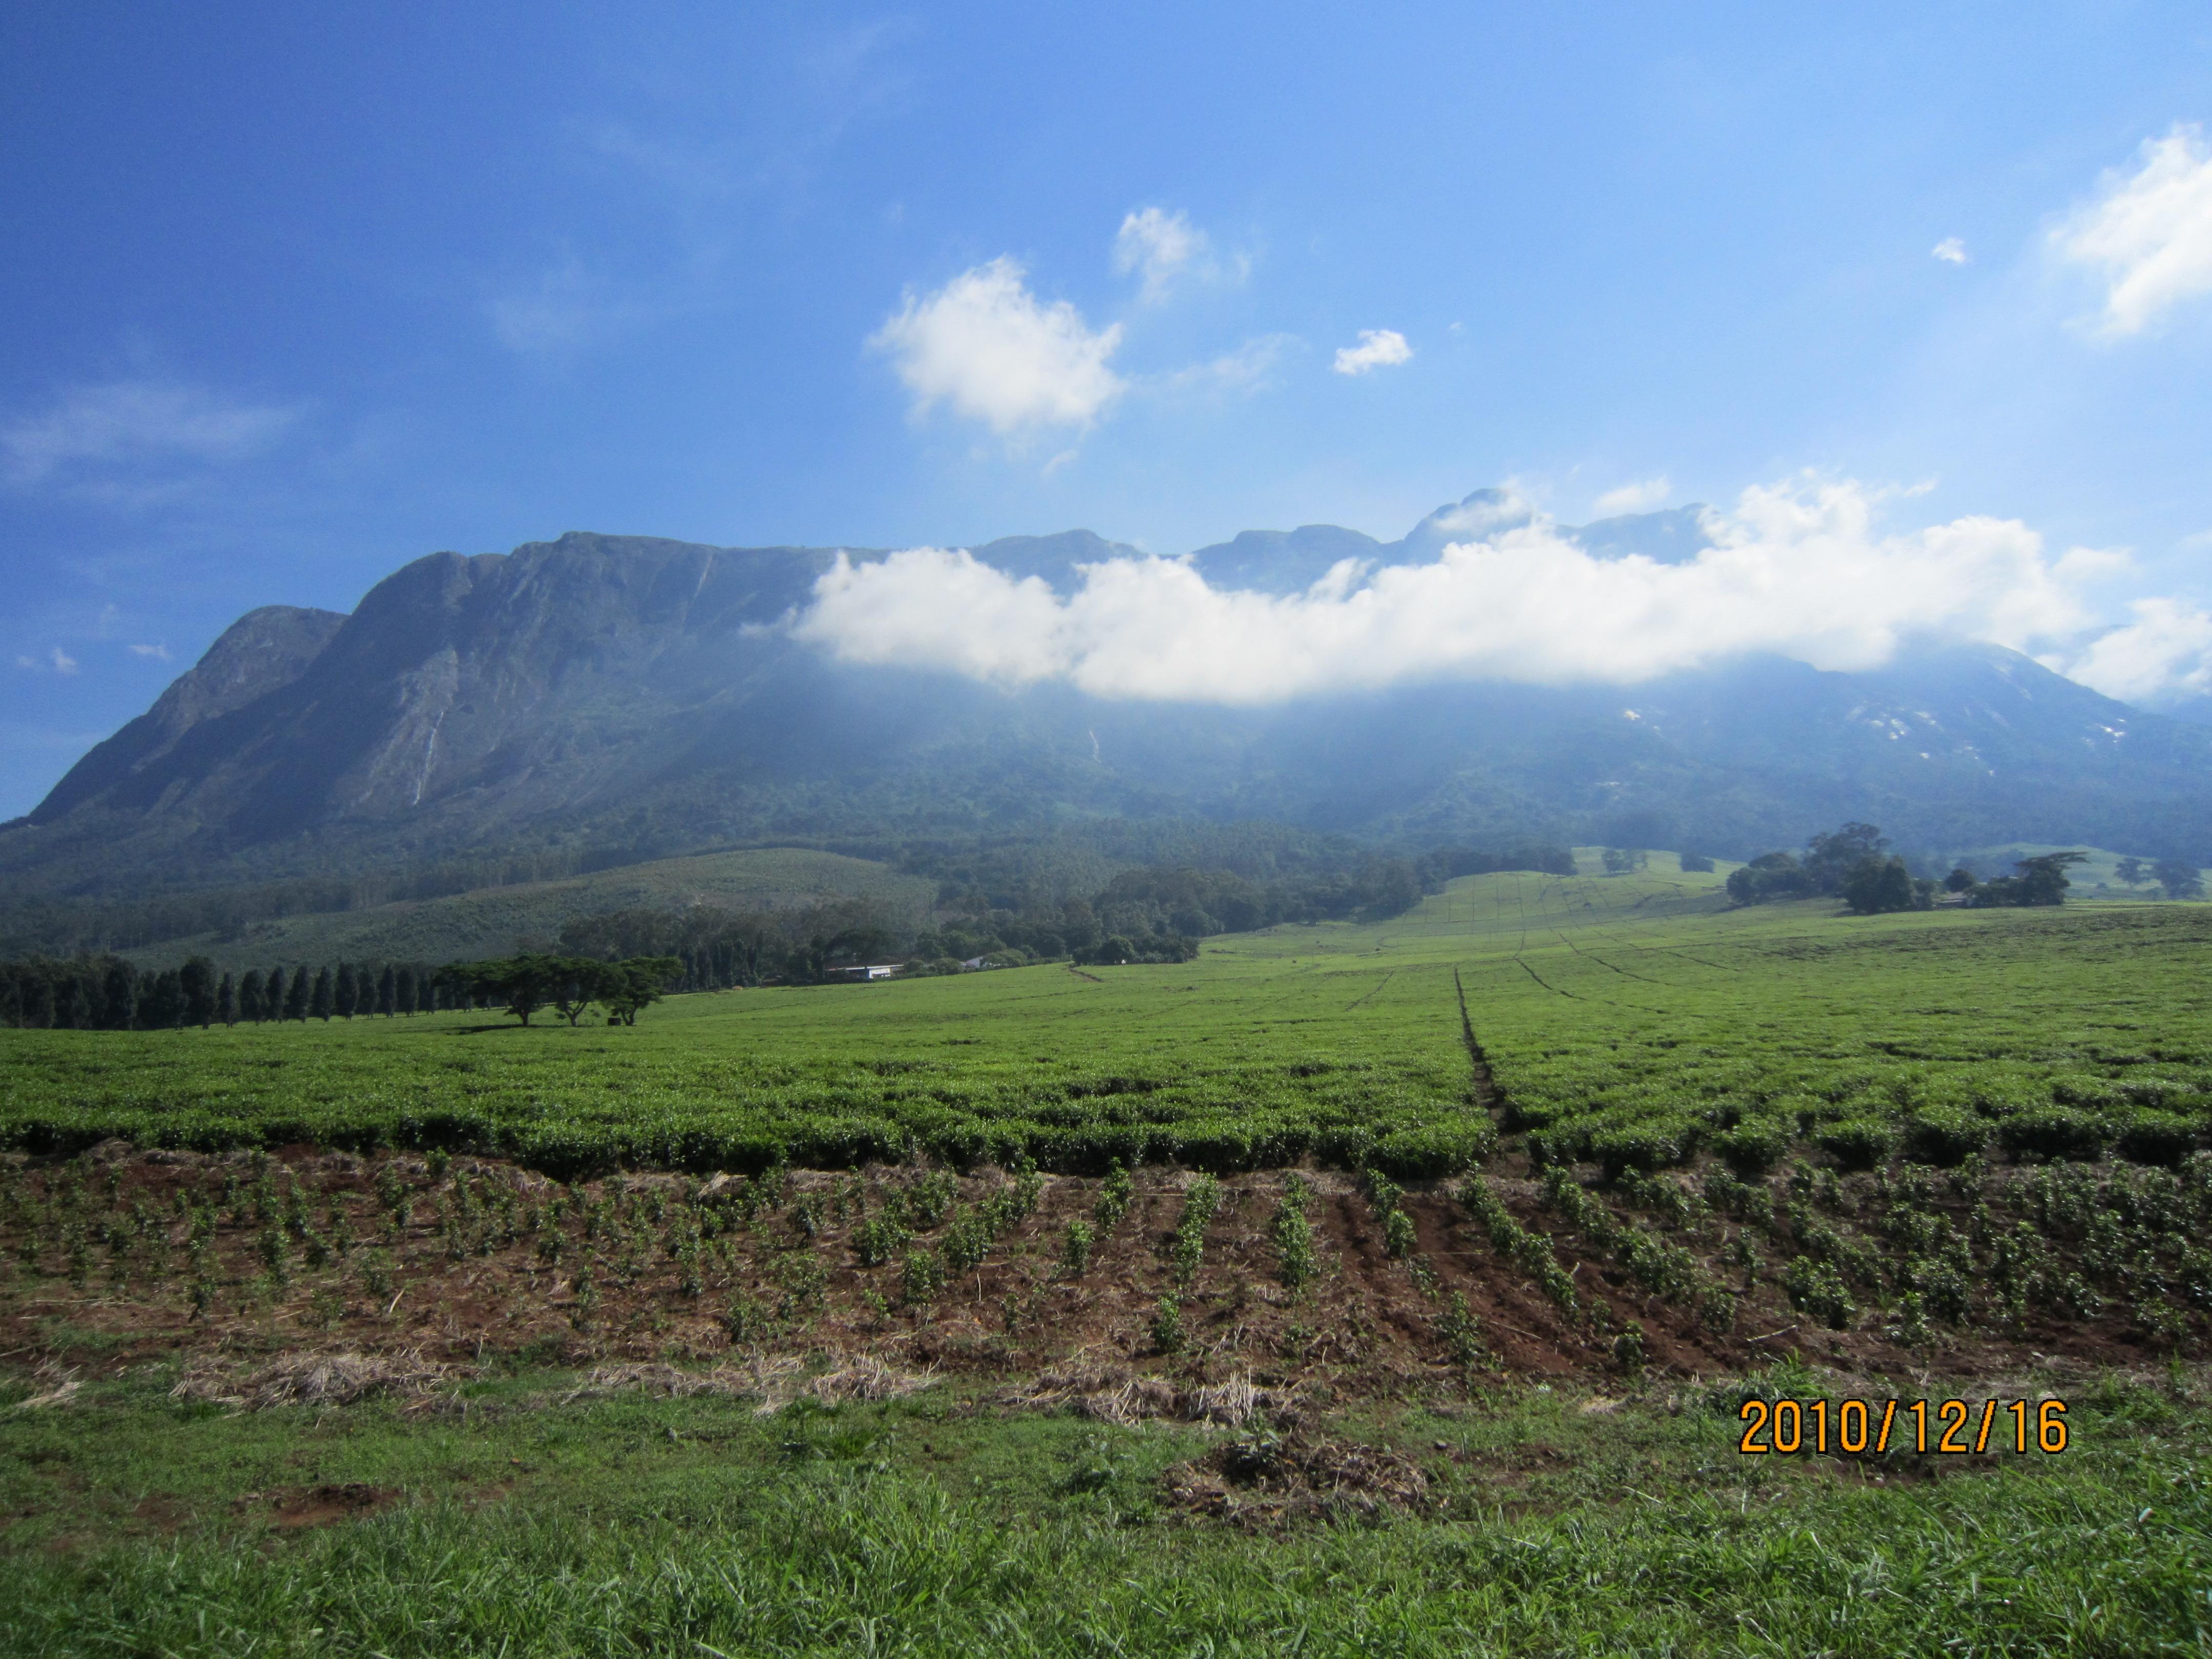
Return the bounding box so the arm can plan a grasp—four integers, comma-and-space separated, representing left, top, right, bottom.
869, 257, 1124, 436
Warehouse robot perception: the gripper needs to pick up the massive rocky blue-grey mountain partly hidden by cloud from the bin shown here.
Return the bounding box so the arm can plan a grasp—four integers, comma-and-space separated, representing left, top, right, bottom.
0, 491, 2212, 931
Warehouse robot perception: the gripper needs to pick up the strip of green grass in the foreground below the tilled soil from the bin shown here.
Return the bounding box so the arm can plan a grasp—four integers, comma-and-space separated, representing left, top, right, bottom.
0, 1374, 2212, 1654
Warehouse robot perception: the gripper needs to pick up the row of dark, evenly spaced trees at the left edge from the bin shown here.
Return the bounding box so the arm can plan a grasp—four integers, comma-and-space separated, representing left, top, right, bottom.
0, 955, 455, 1031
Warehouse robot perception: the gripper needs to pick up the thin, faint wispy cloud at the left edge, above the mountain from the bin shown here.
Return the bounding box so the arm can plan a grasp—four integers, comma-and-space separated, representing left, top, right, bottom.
0, 380, 299, 486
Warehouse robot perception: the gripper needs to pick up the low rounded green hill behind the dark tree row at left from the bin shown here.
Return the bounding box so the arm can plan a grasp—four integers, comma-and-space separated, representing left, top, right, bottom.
129, 847, 935, 971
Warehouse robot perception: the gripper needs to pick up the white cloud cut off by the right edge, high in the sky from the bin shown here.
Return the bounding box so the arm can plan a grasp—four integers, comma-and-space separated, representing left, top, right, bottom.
2053, 126, 2212, 334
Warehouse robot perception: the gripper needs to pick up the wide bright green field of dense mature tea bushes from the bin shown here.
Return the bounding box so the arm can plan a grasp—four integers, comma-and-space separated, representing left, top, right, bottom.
0, 871, 2212, 1179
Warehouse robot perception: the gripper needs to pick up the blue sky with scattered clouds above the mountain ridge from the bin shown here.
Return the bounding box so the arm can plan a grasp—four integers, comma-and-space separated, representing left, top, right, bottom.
0, 5, 2212, 814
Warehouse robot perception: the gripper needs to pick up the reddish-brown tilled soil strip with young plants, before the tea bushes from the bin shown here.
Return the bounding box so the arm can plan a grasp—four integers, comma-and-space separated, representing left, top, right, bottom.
0, 1143, 2152, 1400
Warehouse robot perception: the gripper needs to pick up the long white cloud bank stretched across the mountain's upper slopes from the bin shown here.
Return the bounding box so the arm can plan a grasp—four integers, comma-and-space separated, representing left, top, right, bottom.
792, 478, 2086, 704
